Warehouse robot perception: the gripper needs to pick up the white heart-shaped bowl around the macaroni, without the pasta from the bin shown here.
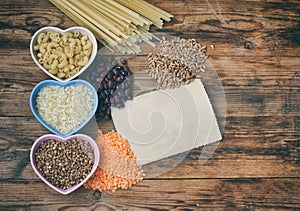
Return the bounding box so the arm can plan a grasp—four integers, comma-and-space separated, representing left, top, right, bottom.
30, 26, 97, 82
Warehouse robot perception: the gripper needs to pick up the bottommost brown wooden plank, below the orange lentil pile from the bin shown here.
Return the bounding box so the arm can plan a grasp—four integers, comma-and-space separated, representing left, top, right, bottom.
0, 178, 300, 210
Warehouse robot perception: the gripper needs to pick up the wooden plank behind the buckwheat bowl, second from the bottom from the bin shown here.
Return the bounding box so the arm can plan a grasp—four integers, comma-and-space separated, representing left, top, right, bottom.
0, 117, 300, 181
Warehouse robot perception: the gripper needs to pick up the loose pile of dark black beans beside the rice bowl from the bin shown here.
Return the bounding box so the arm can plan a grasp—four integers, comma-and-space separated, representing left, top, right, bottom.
83, 56, 133, 120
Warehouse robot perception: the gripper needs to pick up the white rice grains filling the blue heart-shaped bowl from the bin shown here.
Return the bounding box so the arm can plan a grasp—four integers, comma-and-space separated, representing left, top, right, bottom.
36, 84, 94, 134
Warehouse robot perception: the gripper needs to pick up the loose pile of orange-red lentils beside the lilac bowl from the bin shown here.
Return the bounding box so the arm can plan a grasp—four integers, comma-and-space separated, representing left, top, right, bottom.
84, 130, 144, 192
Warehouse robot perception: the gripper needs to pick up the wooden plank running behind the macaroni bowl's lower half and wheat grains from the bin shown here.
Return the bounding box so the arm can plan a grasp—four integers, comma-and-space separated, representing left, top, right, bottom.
0, 53, 300, 86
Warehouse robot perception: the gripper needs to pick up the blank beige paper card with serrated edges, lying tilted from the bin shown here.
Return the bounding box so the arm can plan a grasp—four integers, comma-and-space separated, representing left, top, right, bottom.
112, 79, 222, 164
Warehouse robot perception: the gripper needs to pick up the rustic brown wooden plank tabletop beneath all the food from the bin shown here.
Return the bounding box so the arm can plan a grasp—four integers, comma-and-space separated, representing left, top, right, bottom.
0, 0, 300, 210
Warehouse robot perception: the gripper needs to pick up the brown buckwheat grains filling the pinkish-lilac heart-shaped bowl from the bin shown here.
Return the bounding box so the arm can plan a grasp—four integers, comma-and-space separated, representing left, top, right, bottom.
35, 139, 94, 190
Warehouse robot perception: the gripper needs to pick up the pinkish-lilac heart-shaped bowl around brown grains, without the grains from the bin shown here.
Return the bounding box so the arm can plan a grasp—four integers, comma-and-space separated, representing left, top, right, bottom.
30, 134, 100, 195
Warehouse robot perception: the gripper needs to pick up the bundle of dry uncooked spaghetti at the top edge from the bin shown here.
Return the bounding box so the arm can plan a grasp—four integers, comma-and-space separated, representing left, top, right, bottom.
50, 0, 173, 54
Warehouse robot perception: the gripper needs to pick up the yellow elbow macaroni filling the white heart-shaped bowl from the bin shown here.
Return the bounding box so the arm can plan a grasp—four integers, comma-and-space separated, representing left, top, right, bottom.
34, 31, 93, 79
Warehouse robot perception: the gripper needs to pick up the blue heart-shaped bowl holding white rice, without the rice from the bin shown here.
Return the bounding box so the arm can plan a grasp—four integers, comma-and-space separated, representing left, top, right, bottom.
30, 79, 98, 138
